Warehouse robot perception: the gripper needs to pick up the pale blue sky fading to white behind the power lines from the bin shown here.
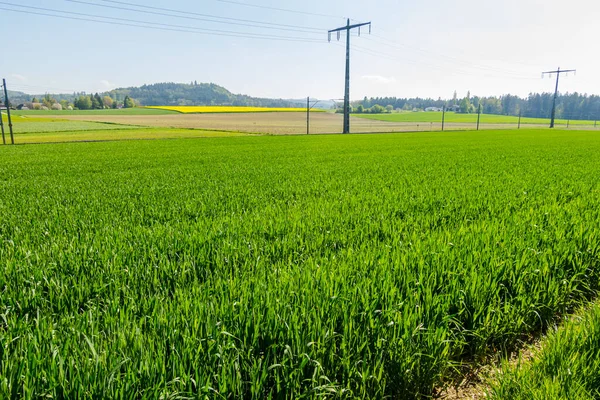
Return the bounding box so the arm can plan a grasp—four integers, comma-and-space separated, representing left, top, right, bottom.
0, 0, 600, 99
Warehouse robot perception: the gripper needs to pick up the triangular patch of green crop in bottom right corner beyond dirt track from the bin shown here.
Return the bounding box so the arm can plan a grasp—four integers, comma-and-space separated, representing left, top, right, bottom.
491, 305, 600, 400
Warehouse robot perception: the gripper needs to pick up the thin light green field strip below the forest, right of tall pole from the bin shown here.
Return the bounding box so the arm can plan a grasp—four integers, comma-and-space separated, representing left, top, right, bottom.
352, 112, 595, 125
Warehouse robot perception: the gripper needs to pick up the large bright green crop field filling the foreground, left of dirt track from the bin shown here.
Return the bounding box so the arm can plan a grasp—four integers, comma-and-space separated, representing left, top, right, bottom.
0, 130, 600, 399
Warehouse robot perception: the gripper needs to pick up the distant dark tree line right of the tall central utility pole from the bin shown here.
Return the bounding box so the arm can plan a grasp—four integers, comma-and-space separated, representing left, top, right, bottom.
352, 93, 600, 120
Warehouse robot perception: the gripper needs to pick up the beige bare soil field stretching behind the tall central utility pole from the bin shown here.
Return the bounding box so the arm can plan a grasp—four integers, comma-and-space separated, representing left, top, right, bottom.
28, 112, 556, 135
